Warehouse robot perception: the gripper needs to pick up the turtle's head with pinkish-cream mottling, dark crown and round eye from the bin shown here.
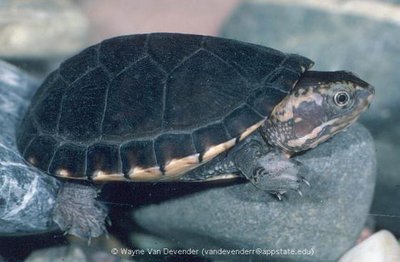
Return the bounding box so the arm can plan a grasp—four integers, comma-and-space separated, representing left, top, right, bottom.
262, 71, 375, 154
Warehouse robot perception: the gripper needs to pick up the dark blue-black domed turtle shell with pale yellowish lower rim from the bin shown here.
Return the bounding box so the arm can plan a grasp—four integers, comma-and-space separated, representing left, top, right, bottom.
17, 33, 313, 181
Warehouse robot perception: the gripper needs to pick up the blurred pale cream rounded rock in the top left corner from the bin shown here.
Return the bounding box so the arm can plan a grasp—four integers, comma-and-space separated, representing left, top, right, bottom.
0, 0, 89, 59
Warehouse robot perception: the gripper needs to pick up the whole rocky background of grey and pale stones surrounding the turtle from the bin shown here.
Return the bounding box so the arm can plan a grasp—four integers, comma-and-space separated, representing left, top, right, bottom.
0, 0, 400, 261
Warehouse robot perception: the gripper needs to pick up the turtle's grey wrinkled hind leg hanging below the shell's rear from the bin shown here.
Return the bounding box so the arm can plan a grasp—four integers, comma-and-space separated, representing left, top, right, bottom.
52, 182, 108, 239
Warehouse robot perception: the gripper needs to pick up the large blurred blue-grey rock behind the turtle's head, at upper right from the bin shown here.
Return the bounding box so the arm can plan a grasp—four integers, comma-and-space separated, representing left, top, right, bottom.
220, 1, 400, 124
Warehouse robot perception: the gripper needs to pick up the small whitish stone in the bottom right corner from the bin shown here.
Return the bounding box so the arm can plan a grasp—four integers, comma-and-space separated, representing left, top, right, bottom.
339, 230, 400, 262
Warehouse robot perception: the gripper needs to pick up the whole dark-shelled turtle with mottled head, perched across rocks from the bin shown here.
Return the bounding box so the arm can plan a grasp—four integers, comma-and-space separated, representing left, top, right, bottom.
17, 33, 375, 239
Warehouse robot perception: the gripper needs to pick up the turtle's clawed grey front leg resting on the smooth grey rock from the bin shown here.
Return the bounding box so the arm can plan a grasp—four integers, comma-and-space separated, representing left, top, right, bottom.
231, 136, 310, 199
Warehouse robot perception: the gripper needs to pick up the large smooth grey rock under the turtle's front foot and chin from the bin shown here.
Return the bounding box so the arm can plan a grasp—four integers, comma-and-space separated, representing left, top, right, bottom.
133, 124, 376, 261
